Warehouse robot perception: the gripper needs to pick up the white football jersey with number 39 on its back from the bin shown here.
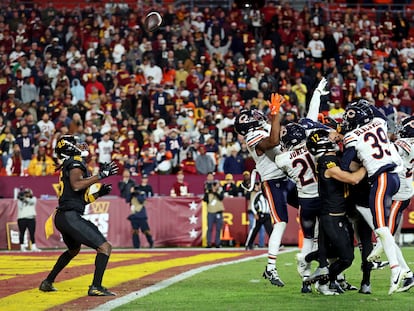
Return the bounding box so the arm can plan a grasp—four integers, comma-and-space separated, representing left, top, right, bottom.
343, 118, 398, 177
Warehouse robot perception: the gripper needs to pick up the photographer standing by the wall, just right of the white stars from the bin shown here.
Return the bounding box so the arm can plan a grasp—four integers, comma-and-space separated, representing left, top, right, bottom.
203, 174, 224, 248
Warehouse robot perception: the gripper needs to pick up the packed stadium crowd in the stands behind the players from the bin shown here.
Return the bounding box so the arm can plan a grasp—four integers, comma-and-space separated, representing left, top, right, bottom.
0, 1, 414, 176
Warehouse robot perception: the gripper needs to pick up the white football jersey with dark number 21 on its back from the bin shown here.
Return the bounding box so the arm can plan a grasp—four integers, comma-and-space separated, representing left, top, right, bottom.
275, 144, 319, 198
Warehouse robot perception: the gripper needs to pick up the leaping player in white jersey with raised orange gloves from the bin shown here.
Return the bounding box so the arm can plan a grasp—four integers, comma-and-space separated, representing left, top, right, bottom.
234, 94, 288, 286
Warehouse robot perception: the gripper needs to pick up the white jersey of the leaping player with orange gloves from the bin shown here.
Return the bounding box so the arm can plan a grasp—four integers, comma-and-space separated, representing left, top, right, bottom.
244, 130, 286, 181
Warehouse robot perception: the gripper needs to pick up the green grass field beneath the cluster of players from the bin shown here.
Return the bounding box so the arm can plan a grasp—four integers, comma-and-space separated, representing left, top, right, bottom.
116, 247, 414, 311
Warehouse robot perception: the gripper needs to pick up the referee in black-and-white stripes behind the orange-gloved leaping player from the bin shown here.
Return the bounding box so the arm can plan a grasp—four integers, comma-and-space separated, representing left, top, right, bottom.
246, 182, 273, 250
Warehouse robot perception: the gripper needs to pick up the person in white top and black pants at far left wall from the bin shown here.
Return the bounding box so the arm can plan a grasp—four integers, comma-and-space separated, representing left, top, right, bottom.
17, 188, 40, 252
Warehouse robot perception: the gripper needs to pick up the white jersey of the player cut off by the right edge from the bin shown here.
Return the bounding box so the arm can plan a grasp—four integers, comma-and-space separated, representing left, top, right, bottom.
392, 138, 414, 201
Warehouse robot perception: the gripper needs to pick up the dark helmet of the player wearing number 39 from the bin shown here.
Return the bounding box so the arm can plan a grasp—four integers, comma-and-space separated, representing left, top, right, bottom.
341, 99, 374, 133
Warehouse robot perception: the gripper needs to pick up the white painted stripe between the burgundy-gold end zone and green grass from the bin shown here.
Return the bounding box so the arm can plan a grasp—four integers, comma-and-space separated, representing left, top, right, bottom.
91, 248, 297, 311
